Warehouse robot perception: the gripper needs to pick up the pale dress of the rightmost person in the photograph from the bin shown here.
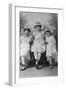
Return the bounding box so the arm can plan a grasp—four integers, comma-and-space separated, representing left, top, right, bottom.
46, 36, 57, 62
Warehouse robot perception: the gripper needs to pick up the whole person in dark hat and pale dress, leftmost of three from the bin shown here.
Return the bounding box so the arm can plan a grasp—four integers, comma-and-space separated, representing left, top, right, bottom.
20, 28, 31, 70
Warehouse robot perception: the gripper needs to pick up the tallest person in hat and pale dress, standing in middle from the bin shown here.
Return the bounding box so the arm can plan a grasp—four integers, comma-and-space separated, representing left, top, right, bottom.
31, 22, 45, 69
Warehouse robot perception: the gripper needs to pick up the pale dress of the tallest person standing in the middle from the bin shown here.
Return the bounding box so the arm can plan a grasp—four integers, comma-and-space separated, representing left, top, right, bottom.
31, 31, 45, 53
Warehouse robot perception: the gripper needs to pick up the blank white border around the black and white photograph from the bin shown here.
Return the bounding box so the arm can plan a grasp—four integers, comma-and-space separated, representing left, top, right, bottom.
12, 5, 63, 85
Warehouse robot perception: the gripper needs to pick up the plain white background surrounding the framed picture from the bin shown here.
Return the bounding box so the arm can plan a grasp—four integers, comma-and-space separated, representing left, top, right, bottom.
0, 0, 66, 90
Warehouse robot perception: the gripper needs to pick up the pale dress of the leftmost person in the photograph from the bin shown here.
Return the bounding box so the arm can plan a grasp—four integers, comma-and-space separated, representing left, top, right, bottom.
20, 36, 31, 58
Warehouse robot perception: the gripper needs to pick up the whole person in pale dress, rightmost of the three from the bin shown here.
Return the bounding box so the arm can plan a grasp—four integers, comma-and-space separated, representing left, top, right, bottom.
45, 30, 57, 69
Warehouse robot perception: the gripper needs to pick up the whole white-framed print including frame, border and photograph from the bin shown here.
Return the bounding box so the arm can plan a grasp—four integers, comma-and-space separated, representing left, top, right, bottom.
9, 4, 63, 85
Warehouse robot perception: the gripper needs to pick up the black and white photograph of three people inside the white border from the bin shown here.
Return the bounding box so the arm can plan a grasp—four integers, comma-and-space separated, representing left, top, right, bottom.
19, 11, 58, 78
